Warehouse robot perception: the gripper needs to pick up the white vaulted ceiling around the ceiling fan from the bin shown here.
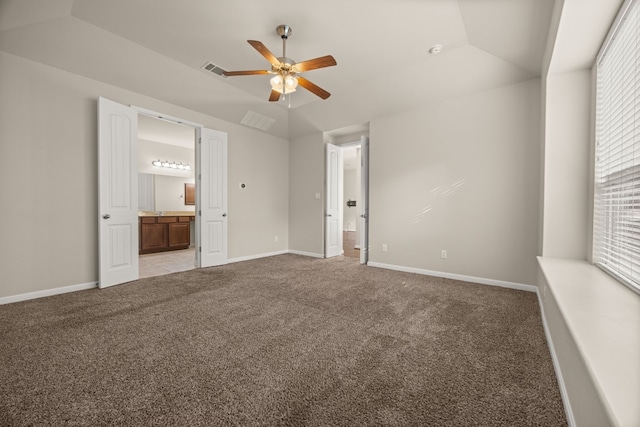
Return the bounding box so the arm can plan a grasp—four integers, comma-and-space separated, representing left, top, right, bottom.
0, 0, 554, 138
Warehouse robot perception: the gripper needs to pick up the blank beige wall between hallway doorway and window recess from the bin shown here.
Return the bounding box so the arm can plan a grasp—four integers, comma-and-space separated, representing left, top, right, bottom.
370, 79, 541, 285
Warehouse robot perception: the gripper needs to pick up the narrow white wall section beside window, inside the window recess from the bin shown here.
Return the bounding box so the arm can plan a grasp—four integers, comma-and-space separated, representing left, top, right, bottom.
542, 70, 592, 259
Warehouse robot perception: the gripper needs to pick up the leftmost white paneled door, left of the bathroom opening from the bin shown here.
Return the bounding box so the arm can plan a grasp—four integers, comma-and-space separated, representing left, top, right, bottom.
98, 98, 138, 288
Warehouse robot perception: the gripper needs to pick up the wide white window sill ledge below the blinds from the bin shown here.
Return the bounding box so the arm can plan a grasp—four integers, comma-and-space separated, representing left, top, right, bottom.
538, 257, 640, 426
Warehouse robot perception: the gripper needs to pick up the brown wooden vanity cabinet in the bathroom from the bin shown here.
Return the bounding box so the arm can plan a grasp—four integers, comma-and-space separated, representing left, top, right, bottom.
138, 216, 193, 254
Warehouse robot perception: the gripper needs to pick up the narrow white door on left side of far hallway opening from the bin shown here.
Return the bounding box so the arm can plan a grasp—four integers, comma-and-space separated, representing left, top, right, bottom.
325, 144, 343, 258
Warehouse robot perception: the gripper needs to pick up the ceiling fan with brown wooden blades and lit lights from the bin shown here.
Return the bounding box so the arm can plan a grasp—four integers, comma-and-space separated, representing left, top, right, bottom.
224, 25, 337, 102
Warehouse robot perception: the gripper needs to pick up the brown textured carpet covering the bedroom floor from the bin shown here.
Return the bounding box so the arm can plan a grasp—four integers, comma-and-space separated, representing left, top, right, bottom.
0, 255, 566, 426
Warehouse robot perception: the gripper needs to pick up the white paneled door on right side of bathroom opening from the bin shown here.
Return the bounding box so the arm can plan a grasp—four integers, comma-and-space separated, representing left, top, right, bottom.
201, 128, 228, 267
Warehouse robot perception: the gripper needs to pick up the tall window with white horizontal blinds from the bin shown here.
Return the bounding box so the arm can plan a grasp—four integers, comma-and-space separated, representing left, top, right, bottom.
593, 0, 640, 293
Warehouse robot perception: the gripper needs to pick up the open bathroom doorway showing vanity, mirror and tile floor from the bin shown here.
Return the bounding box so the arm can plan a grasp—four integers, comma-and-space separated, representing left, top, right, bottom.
138, 114, 197, 279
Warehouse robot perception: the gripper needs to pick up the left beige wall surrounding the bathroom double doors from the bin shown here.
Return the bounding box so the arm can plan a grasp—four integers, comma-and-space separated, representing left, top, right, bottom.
0, 52, 289, 297
